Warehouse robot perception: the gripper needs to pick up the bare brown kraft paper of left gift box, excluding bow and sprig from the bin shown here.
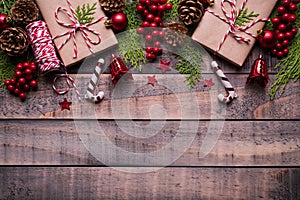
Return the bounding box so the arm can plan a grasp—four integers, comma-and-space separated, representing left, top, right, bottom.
36, 0, 118, 67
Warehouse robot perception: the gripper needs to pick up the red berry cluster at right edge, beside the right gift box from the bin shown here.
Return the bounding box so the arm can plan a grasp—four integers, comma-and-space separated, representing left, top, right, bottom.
271, 0, 300, 58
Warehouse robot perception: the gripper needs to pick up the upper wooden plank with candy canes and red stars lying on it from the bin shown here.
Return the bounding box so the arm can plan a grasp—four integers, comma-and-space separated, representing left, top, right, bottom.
0, 74, 300, 120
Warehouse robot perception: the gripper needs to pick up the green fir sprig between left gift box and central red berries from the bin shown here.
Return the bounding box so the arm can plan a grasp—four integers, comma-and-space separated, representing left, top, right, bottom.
118, 29, 146, 70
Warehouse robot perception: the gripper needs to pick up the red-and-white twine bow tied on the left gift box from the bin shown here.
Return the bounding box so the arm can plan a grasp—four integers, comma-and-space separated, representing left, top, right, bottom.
53, 0, 106, 58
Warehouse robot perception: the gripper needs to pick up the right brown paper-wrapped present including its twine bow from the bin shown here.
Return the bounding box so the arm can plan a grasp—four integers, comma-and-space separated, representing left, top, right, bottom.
192, 0, 277, 66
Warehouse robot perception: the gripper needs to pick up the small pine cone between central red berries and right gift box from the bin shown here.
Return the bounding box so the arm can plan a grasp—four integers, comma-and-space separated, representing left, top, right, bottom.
165, 22, 188, 47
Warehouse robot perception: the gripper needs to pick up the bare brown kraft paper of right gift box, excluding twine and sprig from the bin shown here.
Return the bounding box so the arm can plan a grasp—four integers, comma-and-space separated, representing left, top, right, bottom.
192, 0, 277, 66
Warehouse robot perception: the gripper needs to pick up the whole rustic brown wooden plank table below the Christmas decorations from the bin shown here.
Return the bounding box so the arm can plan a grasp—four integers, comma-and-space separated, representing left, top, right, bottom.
0, 44, 300, 199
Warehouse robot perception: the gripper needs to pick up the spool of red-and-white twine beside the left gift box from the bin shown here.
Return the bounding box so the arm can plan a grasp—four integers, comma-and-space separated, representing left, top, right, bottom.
26, 20, 61, 73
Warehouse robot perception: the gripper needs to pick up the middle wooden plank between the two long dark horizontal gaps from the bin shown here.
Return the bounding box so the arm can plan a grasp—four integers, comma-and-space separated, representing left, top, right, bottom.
0, 120, 300, 166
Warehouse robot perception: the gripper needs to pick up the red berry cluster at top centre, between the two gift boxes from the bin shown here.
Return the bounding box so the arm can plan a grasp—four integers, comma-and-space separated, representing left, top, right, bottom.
136, 0, 173, 61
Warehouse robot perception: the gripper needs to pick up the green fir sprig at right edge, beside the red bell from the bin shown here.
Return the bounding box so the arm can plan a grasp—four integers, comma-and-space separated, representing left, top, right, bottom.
270, 34, 300, 100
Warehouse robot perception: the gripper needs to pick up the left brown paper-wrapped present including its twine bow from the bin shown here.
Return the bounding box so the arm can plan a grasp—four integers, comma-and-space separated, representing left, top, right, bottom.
36, 0, 118, 66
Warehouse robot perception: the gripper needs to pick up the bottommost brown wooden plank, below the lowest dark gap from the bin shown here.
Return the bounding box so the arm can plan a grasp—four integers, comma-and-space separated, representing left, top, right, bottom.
0, 167, 300, 200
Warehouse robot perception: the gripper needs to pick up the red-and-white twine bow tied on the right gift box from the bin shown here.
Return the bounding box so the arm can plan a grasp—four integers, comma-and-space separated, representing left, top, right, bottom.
206, 0, 269, 52
